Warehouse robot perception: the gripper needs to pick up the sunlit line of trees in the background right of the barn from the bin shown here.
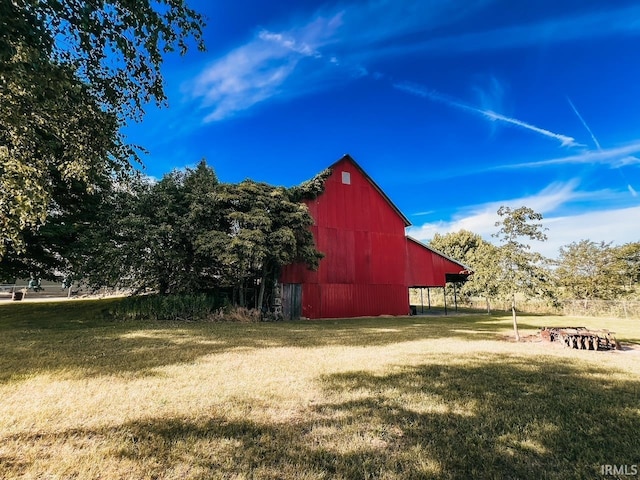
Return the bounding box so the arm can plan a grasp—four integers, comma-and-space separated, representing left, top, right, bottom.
429, 212, 640, 308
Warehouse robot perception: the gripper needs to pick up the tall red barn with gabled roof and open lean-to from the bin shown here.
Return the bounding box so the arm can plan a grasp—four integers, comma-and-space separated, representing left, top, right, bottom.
280, 155, 469, 318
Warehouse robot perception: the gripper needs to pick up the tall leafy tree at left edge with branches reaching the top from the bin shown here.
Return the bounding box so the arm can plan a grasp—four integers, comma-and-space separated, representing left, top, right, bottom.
0, 0, 203, 259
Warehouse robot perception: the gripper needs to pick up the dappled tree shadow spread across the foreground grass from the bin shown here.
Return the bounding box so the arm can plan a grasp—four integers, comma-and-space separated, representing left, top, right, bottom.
3, 355, 640, 479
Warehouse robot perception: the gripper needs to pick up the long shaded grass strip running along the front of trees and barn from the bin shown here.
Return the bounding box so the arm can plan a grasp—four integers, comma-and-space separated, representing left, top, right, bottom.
0, 299, 524, 382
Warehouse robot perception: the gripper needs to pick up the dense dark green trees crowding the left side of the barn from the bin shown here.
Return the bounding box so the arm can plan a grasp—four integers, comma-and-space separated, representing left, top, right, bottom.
0, 160, 330, 307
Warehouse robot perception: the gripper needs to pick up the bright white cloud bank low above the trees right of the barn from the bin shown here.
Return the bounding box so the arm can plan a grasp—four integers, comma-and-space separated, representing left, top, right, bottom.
408, 181, 640, 258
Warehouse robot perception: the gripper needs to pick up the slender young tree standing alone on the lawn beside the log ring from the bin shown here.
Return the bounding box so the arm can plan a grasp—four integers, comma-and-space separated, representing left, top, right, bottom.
494, 206, 551, 341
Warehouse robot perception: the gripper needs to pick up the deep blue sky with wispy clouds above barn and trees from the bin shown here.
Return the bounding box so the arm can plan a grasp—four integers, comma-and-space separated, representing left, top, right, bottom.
125, 0, 640, 257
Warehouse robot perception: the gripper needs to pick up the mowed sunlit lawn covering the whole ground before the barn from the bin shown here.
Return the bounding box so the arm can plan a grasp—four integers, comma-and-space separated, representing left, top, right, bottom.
0, 300, 640, 479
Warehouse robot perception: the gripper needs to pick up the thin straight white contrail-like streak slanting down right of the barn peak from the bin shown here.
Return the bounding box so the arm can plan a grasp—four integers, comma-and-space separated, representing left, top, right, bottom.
393, 82, 580, 147
